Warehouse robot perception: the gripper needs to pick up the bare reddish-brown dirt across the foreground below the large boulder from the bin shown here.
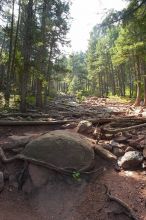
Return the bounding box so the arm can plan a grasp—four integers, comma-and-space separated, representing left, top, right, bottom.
0, 126, 146, 220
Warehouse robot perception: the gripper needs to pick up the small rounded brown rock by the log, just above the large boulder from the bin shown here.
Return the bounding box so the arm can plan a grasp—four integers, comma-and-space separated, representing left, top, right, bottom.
77, 120, 93, 134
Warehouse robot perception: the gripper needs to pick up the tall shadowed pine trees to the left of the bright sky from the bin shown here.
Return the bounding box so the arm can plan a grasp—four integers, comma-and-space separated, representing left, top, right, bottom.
0, 0, 70, 111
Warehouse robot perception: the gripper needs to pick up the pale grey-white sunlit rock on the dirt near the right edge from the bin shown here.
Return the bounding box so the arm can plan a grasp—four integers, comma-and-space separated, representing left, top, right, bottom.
118, 151, 143, 169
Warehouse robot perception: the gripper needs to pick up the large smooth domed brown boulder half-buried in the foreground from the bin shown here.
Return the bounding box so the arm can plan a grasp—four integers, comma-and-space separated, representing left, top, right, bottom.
21, 130, 94, 171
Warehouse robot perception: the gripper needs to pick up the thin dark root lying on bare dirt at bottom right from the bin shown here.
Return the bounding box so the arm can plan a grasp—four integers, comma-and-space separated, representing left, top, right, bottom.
104, 185, 138, 220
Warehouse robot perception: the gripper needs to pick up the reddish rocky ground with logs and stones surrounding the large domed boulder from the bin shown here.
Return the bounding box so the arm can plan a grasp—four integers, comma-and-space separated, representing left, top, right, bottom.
0, 96, 146, 220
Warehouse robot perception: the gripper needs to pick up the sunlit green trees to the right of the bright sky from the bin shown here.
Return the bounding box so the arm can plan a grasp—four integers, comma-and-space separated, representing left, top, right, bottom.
87, 0, 146, 100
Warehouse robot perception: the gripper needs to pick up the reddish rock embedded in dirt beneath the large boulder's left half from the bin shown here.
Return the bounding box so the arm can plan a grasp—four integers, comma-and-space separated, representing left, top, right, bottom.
28, 164, 50, 187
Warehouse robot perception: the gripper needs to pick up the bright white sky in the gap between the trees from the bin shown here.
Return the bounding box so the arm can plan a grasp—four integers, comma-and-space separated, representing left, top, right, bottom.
68, 0, 126, 51
